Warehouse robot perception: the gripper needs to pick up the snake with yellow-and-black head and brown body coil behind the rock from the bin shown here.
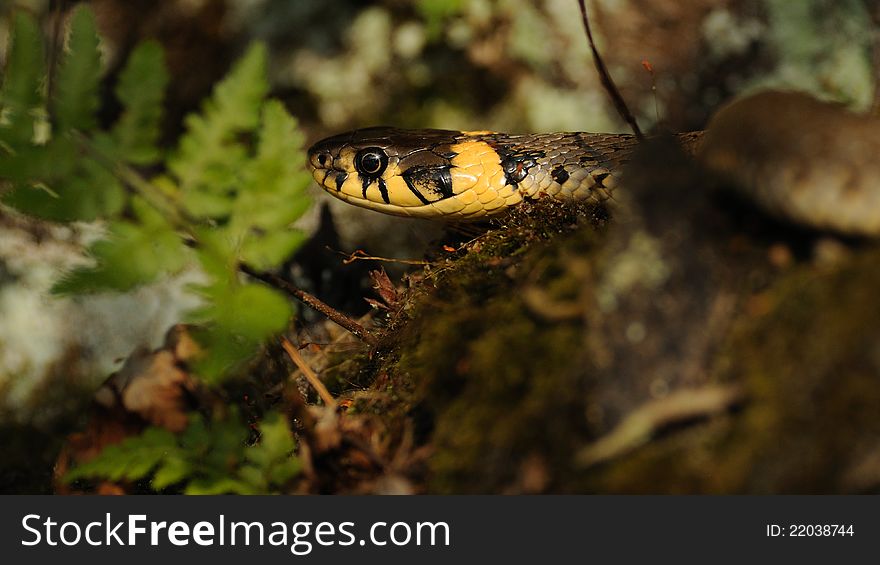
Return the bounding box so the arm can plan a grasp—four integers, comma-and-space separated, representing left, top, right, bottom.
308, 91, 880, 236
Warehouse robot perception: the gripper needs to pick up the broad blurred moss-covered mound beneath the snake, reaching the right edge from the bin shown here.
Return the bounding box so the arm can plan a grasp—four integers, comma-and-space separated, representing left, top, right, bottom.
326, 174, 880, 493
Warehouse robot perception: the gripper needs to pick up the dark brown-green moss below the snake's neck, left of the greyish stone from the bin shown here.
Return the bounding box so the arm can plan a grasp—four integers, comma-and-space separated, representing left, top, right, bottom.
342, 198, 605, 492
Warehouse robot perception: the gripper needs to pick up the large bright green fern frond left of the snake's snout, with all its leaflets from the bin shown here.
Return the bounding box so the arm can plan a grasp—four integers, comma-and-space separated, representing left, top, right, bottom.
0, 22, 310, 384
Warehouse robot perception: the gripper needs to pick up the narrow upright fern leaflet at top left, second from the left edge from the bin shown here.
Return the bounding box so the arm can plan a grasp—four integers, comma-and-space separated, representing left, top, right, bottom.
52, 6, 101, 131
